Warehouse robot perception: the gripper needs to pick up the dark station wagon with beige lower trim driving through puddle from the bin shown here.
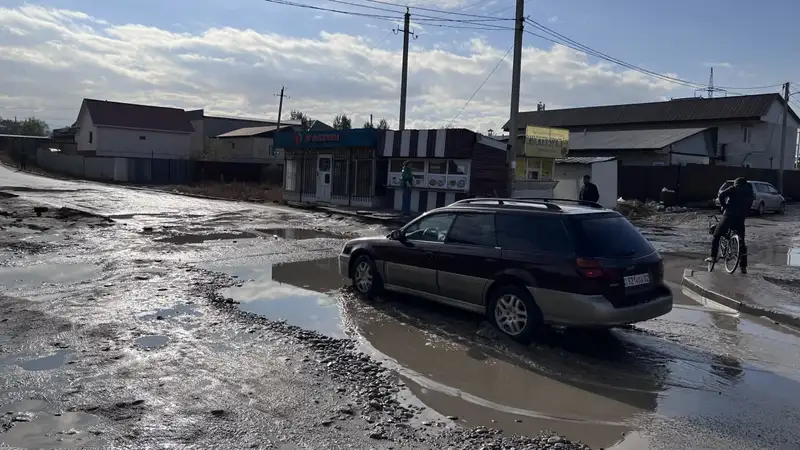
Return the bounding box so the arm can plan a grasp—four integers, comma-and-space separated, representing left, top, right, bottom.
339, 198, 673, 342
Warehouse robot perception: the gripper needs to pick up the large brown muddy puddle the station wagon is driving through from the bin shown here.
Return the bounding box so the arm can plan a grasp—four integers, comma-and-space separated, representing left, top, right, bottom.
206, 255, 800, 449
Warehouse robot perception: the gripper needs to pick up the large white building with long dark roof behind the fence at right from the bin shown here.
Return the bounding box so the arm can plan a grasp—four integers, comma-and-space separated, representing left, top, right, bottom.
504, 94, 800, 169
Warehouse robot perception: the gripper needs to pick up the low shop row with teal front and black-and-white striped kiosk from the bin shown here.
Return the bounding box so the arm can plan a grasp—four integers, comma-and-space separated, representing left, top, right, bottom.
275, 129, 508, 213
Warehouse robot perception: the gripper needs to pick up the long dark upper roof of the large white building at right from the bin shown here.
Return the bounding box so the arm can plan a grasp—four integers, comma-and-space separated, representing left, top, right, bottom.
503, 93, 800, 130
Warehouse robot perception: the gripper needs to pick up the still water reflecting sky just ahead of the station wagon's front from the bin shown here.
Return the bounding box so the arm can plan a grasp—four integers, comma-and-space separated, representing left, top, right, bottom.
222, 259, 344, 336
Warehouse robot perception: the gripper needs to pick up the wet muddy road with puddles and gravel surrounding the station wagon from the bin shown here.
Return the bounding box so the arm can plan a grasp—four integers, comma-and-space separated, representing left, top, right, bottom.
0, 168, 800, 449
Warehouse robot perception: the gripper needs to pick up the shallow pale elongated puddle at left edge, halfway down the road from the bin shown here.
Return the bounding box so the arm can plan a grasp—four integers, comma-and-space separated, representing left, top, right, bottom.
0, 264, 100, 288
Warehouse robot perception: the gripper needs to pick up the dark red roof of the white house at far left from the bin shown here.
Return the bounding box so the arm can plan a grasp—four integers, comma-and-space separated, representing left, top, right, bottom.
83, 98, 194, 133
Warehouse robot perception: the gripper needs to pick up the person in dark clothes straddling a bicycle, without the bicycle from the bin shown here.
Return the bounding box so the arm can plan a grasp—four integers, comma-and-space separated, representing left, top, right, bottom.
706, 177, 755, 273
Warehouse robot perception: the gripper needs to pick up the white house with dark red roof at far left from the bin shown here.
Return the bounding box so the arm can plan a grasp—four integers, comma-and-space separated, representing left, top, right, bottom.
75, 98, 194, 159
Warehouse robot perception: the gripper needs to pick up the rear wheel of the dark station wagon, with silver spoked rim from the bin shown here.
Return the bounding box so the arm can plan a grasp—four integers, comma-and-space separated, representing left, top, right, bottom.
489, 284, 543, 344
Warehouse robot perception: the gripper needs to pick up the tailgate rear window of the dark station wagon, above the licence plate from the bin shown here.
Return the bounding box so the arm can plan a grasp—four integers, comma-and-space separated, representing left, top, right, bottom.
575, 216, 655, 258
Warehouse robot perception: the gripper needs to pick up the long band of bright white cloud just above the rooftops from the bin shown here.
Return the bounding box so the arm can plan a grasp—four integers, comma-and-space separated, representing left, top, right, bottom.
0, 5, 676, 131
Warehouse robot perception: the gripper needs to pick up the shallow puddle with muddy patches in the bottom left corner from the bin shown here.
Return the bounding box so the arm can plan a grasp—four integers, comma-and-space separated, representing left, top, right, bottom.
0, 400, 103, 448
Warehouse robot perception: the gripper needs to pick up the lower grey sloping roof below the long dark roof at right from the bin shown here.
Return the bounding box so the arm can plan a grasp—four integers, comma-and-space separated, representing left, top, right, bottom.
569, 128, 708, 151
